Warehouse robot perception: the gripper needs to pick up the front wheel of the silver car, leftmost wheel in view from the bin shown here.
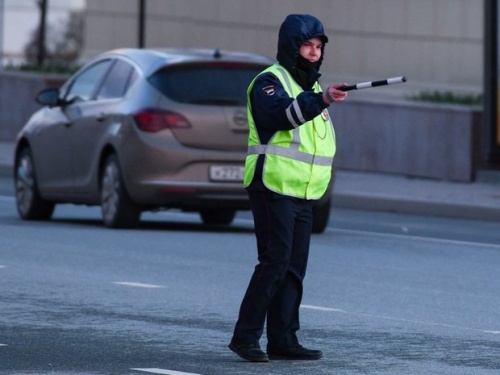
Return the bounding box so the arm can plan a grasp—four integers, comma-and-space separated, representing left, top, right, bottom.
14, 148, 55, 220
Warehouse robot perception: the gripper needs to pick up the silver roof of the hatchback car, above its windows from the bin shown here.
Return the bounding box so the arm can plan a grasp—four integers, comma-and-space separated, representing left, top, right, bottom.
94, 48, 274, 75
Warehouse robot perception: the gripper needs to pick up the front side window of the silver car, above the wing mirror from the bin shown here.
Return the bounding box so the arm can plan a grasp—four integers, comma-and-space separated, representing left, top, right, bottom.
65, 60, 111, 102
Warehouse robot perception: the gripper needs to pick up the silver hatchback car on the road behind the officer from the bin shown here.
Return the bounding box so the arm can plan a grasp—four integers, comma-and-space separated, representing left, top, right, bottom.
14, 49, 331, 233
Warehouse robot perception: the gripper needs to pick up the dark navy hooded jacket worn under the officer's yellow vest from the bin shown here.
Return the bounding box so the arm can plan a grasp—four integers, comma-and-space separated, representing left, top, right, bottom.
250, 14, 328, 188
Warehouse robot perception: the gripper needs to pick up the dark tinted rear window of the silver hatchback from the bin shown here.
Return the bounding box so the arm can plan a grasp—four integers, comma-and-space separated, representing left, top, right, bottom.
149, 62, 266, 106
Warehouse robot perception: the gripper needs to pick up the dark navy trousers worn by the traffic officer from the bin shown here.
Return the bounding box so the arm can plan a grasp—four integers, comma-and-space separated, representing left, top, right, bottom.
233, 190, 312, 349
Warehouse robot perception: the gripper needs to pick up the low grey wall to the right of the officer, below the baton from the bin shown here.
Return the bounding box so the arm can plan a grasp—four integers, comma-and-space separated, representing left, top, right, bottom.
330, 99, 482, 181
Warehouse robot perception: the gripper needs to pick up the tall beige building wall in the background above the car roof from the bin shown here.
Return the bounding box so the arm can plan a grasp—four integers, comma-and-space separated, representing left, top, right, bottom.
84, 0, 484, 96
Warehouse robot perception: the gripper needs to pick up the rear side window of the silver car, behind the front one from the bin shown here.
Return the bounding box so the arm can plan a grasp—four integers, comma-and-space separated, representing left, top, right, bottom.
97, 60, 137, 99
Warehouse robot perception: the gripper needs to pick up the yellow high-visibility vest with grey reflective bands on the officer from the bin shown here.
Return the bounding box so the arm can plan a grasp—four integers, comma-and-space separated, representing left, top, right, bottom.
243, 64, 336, 199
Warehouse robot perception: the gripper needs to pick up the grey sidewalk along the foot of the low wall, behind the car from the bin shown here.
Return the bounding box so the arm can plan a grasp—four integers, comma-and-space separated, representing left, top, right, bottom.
0, 142, 500, 221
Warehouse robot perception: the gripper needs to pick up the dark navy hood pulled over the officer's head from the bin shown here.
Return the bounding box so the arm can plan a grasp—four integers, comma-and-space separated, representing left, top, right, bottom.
276, 14, 328, 71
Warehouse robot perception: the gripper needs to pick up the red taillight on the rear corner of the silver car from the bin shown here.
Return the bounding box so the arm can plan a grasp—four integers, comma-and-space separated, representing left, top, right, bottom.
134, 109, 191, 133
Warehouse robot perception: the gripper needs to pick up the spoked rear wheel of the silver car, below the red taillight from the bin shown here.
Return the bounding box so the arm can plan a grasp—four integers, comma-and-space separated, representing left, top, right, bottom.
101, 155, 141, 228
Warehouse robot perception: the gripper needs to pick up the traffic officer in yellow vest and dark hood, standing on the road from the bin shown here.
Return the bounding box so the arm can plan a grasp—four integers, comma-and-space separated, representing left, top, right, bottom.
229, 14, 347, 362
